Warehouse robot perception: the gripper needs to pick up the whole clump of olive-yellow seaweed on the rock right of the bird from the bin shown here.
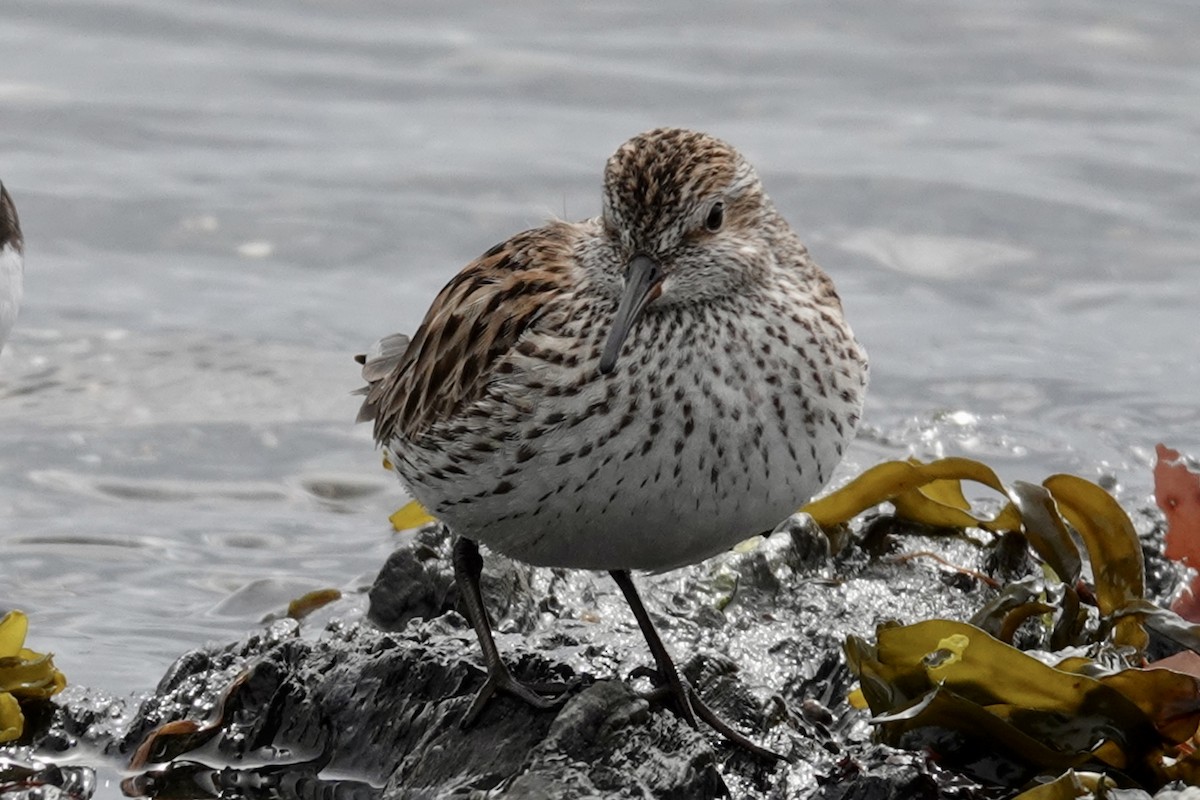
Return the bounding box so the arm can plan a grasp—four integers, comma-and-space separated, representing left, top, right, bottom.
804, 458, 1200, 800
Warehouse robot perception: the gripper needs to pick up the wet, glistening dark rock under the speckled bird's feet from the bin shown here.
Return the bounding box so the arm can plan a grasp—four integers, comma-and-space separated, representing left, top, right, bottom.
0, 510, 1190, 800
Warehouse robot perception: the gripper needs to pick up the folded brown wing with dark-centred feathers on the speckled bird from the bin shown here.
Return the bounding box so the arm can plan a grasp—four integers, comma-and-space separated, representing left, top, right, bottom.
359, 222, 575, 444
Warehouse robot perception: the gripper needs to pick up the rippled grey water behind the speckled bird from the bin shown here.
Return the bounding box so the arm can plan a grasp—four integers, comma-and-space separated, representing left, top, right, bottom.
0, 0, 1200, 738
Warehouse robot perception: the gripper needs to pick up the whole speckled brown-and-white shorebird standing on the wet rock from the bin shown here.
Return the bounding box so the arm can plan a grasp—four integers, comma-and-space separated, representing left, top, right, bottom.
356, 127, 869, 758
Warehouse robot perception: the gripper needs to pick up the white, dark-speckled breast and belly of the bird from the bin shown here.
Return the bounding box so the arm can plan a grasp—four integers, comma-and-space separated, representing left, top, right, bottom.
389, 291, 865, 570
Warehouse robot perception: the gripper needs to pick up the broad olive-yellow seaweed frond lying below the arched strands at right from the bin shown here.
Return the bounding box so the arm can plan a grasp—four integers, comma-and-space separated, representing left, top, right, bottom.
846, 619, 1200, 772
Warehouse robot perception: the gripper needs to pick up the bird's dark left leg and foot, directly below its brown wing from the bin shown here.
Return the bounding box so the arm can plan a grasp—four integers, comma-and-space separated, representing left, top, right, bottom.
454, 536, 566, 728
